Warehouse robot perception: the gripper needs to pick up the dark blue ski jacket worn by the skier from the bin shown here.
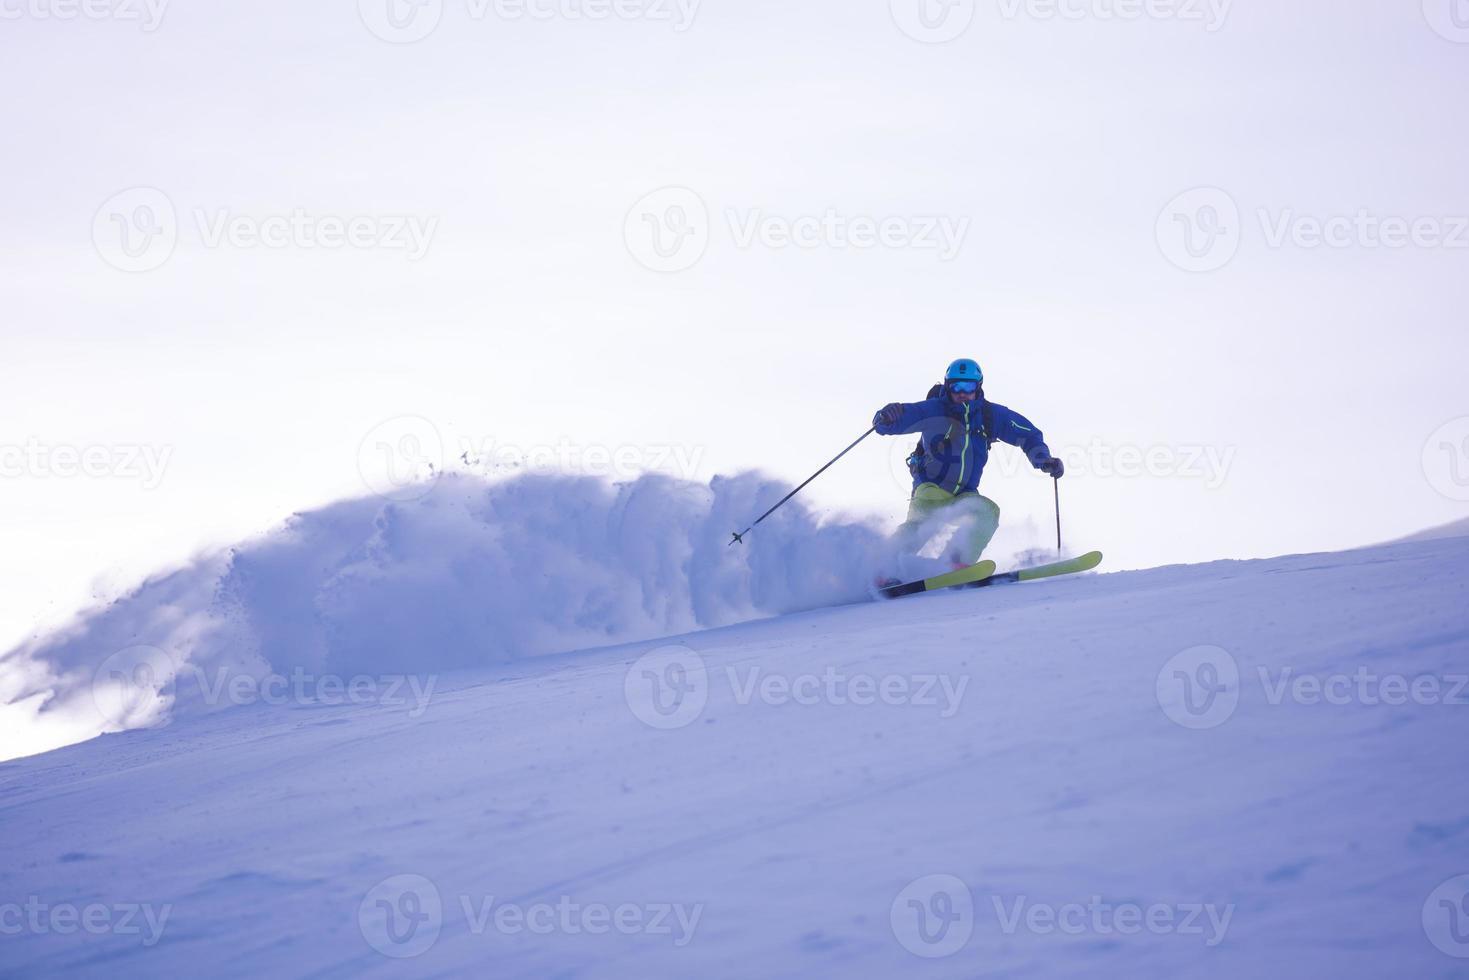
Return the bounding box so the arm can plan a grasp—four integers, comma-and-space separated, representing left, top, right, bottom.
873, 395, 1050, 494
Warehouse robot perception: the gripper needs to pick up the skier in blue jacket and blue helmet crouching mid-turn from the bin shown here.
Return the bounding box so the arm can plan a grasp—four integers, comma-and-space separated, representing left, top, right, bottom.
873, 357, 1065, 567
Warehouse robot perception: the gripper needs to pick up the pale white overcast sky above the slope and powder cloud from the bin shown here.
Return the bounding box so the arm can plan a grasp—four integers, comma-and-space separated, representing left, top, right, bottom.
0, 0, 1469, 649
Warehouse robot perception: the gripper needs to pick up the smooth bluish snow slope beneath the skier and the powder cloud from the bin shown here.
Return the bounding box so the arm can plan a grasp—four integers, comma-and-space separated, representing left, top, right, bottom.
0, 487, 1469, 977
